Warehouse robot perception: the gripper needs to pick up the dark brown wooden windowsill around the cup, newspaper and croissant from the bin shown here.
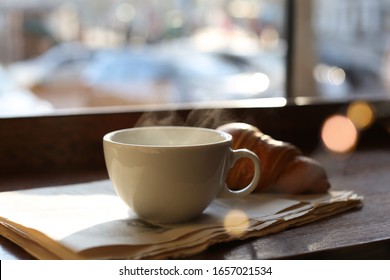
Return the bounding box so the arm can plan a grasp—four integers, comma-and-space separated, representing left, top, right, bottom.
0, 99, 390, 259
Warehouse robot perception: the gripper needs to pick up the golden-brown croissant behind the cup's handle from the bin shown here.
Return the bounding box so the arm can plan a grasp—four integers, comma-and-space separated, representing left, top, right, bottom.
217, 123, 330, 194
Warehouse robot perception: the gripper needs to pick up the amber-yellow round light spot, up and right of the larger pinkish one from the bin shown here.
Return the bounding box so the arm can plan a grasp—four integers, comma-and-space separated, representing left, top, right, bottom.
347, 101, 375, 129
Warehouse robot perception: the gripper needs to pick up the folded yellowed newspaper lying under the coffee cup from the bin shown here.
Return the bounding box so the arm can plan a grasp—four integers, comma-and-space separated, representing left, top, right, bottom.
0, 180, 363, 259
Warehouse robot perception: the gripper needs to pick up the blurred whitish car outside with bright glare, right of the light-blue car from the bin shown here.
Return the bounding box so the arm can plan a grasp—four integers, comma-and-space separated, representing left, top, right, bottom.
170, 52, 270, 102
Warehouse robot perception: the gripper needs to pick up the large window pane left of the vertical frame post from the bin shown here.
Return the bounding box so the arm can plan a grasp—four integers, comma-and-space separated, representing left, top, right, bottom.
0, 0, 286, 114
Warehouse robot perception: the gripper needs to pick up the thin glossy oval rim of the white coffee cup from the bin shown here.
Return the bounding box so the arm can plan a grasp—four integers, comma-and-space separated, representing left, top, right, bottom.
103, 125, 233, 149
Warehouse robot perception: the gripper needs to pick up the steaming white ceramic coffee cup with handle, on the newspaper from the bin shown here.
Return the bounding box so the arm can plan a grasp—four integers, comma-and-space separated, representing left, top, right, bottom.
103, 126, 261, 223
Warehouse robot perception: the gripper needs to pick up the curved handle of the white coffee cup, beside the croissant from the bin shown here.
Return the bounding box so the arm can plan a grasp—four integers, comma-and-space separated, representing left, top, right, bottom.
219, 149, 261, 198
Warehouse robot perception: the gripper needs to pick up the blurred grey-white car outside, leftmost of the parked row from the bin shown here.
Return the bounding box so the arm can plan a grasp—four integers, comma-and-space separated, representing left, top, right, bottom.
8, 42, 95, 108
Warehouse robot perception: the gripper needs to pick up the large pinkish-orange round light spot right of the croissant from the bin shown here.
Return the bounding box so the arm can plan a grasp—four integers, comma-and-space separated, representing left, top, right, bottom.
321, 115, 358, 154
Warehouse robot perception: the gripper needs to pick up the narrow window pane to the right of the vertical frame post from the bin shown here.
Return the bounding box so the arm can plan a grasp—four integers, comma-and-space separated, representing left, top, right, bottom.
312, 0, 390, 98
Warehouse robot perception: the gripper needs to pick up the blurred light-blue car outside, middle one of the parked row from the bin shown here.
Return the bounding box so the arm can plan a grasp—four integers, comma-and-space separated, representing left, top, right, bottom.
82, 49, 177, 106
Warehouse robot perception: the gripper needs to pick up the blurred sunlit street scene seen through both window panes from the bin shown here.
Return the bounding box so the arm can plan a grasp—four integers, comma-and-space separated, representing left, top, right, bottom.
0, 0, 390, 116
